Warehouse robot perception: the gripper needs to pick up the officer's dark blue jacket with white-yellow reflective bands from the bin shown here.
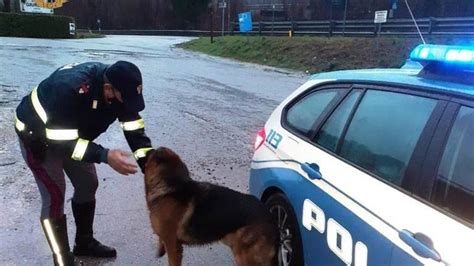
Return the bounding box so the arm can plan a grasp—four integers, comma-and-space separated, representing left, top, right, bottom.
16, 62, 151, 171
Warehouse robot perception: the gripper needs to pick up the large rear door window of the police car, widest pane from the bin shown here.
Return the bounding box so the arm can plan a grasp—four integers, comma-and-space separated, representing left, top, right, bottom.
340, 90, 437, 186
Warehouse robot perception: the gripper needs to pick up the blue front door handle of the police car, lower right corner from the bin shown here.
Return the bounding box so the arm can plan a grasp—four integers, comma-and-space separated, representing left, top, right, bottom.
398, 229, 441, 261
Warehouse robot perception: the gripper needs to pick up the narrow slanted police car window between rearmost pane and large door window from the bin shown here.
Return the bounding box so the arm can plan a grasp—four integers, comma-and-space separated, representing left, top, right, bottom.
315, 90, 362, 152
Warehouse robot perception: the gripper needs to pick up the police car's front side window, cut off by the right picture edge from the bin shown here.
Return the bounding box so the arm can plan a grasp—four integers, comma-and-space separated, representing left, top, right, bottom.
433, 107, 474, 223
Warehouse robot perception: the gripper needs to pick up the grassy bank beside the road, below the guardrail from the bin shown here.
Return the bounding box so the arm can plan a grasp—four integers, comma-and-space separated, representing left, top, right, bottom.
178, 36, 474, 73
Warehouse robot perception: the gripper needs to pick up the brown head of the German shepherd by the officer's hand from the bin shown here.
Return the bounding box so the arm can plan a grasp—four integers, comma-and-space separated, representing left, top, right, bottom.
145, 147, 190, 190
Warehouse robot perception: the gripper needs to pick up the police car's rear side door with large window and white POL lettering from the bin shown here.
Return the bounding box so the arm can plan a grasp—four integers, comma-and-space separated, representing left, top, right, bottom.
280, 86, 446, 265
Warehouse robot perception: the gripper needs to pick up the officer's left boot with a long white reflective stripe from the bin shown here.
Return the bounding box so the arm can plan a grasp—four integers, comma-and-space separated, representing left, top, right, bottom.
41, 215, 74, 266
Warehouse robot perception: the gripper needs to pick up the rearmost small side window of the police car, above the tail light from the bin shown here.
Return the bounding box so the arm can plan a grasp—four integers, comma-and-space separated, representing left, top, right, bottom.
286, 90, 338, 134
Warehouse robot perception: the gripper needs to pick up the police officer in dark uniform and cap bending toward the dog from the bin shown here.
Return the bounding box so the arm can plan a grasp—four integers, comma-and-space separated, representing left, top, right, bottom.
15, 61, 151, 265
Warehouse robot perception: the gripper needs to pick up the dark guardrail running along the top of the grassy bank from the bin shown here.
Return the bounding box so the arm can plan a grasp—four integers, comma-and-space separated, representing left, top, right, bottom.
233, 17, 474, 36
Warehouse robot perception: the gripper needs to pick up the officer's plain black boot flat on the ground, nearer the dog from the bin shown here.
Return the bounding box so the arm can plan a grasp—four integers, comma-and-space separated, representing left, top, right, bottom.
72, 201, 117, 258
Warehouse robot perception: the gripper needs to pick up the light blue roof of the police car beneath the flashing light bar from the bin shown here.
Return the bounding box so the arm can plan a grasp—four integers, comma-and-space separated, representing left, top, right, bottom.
310, 63, 474, 96
